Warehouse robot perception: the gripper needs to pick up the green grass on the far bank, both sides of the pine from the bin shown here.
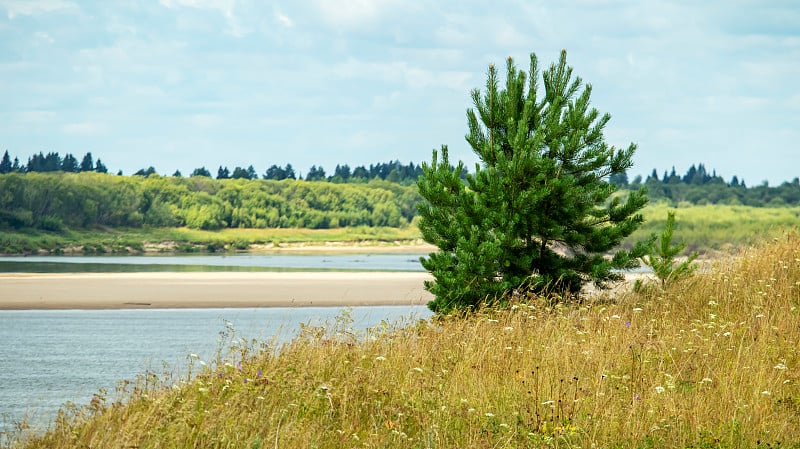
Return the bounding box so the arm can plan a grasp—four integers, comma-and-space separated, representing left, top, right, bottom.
0, 203, 800, 254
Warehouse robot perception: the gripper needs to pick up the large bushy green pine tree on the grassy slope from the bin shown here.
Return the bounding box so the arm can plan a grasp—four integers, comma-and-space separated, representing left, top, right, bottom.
417, 52, 648, 313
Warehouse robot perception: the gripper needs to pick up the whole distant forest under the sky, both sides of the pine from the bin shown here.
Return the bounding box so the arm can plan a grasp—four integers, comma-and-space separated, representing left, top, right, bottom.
0, 151, 800, 231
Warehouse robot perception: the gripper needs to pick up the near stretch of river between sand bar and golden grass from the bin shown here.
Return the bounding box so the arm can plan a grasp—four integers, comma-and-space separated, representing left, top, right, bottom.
0, 306, 430, 436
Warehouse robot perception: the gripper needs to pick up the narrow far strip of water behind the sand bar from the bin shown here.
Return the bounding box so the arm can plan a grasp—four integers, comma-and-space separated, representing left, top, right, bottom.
0, 253, 424, 273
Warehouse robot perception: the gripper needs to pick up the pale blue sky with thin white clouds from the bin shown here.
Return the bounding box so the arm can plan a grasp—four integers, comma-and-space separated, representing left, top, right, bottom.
0, 0, 800, 185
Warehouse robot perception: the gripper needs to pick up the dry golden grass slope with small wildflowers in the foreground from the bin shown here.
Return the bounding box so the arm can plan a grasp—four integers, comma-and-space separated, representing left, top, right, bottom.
7, 233, 800, 449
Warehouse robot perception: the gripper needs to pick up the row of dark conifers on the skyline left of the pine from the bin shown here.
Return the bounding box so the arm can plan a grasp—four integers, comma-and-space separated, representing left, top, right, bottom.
0, 150, 422, 184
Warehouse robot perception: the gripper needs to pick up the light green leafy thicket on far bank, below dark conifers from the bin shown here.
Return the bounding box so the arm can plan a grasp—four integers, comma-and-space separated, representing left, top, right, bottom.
0, 172, 419, 231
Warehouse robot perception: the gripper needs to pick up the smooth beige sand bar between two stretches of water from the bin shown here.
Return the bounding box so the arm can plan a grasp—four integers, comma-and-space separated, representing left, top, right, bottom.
0, 272, 433, 310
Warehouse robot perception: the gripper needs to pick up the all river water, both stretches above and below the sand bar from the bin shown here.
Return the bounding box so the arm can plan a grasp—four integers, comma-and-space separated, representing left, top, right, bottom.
0, 254, 430, 445
